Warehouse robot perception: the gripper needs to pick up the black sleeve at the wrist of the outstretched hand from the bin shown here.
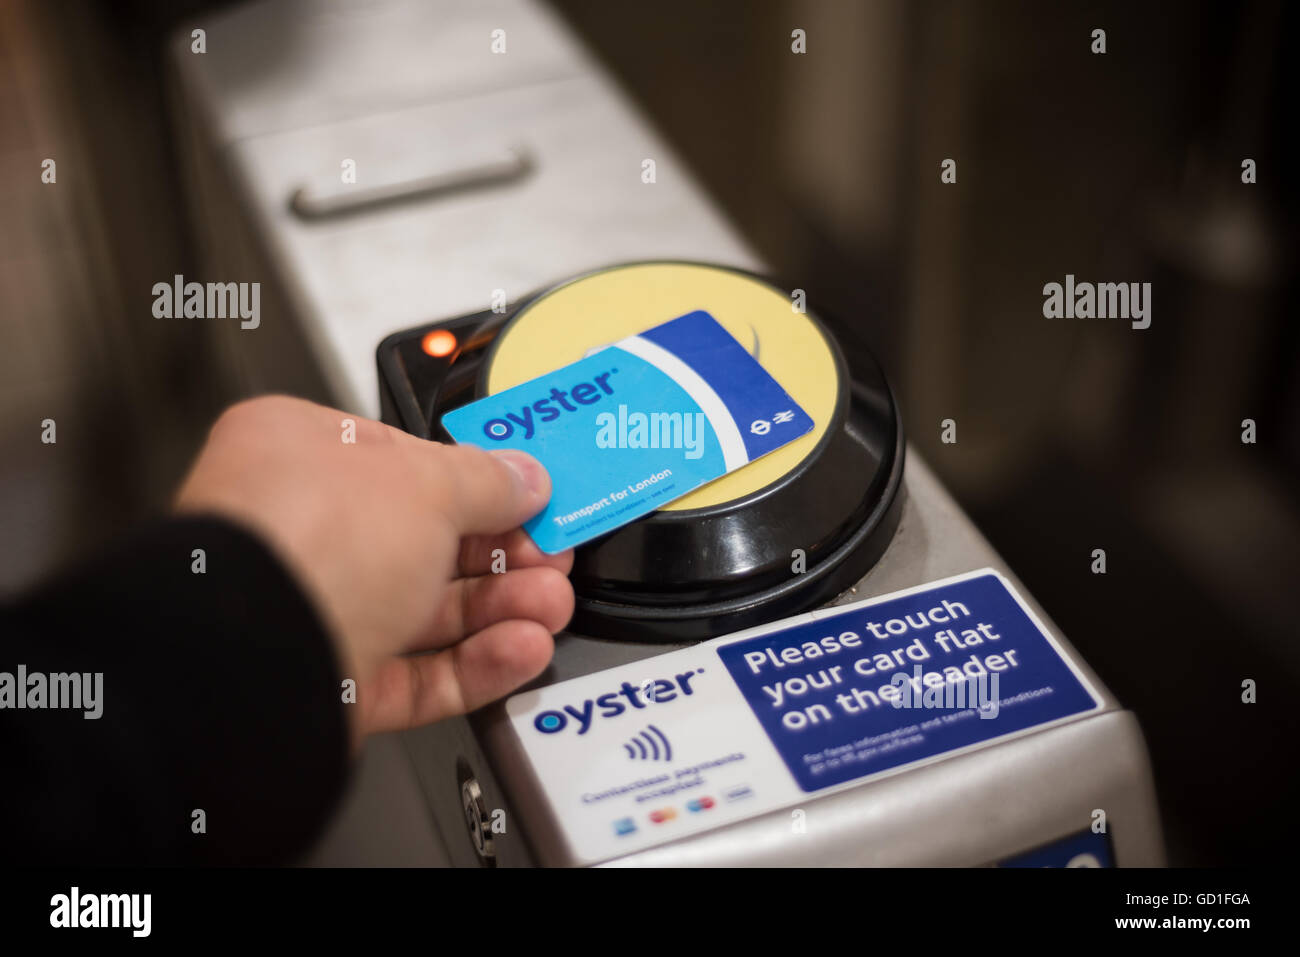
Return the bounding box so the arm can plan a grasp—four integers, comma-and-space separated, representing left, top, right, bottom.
0, 518, 348, 865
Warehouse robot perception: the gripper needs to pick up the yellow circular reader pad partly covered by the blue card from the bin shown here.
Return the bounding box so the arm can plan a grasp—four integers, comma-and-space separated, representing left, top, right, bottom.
488, 263, 840, 511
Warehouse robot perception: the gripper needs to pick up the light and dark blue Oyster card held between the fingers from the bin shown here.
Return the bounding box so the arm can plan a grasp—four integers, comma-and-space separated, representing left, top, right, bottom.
442, 309, 813, 554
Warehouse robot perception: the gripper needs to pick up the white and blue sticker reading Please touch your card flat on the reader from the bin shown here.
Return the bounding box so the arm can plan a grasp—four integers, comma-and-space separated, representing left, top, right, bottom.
506, 568, 1102, 863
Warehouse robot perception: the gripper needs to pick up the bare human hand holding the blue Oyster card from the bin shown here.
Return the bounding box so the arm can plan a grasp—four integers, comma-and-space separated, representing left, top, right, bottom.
176, 397, 573, 737
